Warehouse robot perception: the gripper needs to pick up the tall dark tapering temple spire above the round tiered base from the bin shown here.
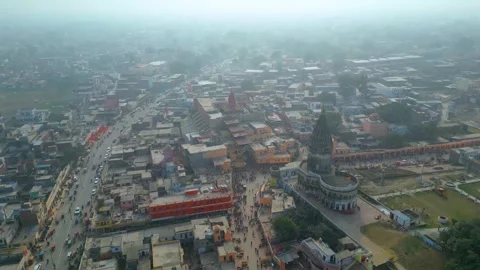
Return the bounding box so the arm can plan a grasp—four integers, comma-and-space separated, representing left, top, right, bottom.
307, 108, 333, 175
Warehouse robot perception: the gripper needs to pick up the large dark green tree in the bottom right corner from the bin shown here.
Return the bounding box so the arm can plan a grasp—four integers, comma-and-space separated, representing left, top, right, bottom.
440, 219, 480, 270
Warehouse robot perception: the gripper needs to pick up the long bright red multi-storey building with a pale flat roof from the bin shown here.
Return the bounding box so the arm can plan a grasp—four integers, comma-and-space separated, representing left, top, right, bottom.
149, 190, 232, 220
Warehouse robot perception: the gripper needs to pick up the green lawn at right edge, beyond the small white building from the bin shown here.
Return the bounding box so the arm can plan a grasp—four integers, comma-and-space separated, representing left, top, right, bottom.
380, 189, 480, 228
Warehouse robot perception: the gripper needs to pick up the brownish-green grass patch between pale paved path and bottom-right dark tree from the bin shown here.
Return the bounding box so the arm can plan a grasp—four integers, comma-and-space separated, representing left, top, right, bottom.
361, 222, 445, 270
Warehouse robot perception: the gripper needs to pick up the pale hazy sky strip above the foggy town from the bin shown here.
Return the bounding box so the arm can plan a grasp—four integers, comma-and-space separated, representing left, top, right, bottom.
0, 0, 480, 19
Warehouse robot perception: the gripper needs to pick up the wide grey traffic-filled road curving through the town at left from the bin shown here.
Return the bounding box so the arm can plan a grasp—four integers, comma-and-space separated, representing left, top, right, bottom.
44, 59, 230, 270
